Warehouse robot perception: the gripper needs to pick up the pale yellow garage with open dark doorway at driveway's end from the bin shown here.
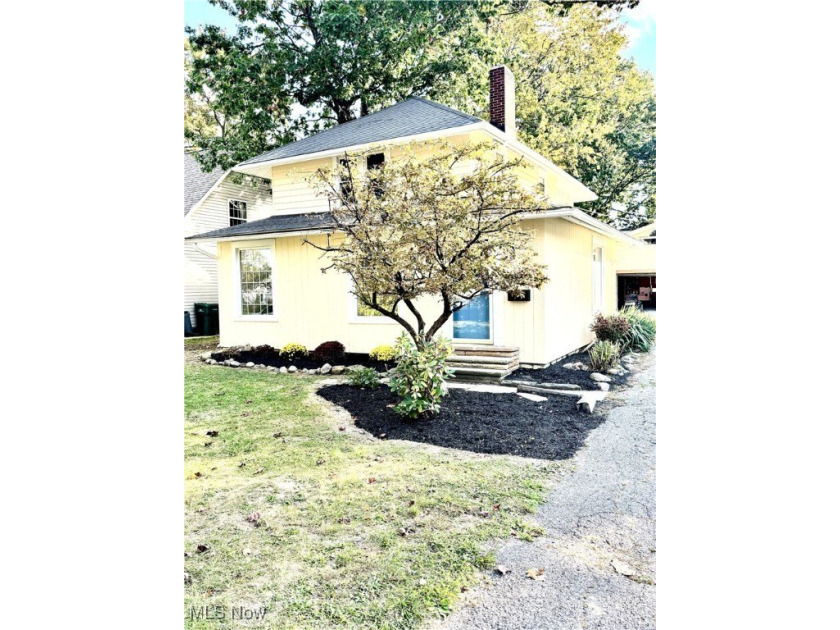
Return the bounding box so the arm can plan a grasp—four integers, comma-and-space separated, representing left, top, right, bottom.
616, 221, 656, 310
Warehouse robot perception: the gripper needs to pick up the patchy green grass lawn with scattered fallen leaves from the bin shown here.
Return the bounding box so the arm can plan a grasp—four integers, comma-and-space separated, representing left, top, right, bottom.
184, 362, 562, 629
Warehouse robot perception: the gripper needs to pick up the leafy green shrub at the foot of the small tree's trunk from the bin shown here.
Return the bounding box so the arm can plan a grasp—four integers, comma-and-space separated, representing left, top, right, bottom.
391, 333, 452, 418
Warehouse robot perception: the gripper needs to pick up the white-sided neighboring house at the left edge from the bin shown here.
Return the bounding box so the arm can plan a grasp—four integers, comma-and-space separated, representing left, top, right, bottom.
184, 153, 271, 334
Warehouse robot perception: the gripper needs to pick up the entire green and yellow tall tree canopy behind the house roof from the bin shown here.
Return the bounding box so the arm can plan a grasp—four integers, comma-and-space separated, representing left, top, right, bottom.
185, 0, 656, 227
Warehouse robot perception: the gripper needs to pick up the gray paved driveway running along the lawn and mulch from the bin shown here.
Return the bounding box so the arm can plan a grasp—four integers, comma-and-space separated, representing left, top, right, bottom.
434, 349, 656, 630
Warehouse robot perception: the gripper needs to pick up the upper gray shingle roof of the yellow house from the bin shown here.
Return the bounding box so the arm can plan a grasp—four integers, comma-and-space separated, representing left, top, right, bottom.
240, 96, 481, 166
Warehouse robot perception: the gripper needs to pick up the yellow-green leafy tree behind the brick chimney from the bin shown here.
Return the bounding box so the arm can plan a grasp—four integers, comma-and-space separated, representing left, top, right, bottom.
440, 2, 656, 227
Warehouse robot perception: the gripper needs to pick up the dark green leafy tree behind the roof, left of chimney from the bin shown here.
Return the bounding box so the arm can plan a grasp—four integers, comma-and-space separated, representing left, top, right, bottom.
187, 0, 496, 167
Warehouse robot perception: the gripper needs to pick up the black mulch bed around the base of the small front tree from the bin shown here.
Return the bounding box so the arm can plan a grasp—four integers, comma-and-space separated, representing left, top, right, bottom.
318, 385, 604, 459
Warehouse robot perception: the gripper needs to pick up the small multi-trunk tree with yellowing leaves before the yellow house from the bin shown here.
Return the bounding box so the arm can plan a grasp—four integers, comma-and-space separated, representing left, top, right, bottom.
307, 142, 548, 346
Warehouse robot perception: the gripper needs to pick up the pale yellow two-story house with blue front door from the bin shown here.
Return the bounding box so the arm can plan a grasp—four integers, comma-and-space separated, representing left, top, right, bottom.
189, 66, 638, 375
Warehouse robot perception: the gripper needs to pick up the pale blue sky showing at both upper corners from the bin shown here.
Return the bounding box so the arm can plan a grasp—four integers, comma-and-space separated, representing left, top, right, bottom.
184, 0, 657, 76
